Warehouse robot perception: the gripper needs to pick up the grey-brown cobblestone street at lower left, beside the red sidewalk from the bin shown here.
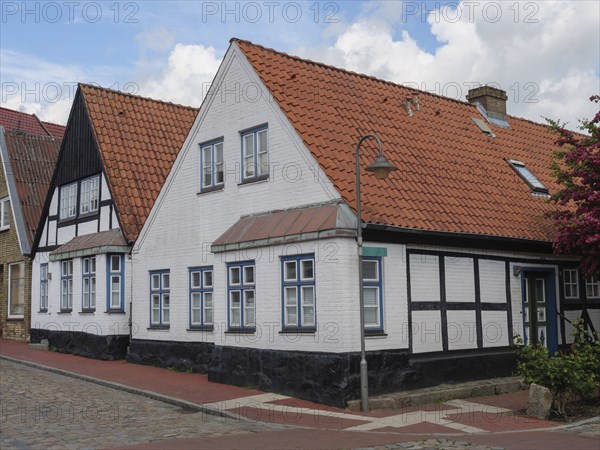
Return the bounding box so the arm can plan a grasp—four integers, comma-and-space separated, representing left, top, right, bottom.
0, 361, 281, 450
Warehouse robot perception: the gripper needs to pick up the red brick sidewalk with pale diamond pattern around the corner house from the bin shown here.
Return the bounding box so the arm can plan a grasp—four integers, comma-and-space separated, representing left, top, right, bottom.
0, 340, 600, 450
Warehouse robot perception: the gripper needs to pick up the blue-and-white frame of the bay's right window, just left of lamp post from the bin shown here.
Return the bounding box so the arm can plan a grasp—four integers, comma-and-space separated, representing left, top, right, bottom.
280, 253, 317, 332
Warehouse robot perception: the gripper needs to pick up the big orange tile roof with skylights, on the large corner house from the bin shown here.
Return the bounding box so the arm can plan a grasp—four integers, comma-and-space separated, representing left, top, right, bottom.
232, 39, 558, 241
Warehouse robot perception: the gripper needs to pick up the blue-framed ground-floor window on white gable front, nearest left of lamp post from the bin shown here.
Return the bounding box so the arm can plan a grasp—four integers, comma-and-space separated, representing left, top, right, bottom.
281, 255, 316, 329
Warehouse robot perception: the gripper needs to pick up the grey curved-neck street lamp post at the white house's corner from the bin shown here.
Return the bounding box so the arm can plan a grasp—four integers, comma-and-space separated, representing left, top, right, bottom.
356, 134, 397, 412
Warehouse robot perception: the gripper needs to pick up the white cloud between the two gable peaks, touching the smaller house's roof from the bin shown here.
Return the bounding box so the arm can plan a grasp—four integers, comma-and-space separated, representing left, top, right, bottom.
140, 44, 221, 107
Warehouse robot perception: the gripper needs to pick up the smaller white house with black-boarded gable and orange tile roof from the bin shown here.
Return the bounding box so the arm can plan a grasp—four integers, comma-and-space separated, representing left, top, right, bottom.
31, 84, 198, 359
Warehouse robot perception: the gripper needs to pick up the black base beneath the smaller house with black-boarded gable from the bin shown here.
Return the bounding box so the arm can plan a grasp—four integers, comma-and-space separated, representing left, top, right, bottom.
30, 328, 129, 360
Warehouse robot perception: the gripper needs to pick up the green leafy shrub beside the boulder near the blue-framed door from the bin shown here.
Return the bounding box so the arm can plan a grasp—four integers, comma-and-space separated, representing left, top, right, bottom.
516, 320, 600, 416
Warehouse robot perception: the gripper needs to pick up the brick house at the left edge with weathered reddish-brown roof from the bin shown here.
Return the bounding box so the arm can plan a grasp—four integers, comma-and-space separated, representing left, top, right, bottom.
0, 107, 64, 340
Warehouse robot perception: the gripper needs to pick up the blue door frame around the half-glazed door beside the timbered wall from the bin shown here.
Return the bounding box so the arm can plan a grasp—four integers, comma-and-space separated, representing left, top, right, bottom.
521, 267, 558, 355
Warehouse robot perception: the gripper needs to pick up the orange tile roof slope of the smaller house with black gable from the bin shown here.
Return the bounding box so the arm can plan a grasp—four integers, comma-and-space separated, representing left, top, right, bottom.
79, 84, 199, 240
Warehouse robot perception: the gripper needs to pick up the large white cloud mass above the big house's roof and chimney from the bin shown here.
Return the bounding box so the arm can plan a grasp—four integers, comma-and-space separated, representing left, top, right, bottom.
298, 1, 600, 127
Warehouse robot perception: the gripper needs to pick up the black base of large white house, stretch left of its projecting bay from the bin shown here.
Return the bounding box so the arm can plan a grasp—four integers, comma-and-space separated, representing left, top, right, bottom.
127, 339, 215, 373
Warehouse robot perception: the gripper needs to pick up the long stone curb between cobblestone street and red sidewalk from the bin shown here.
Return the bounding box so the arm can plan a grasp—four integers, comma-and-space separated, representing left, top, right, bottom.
0, 355, 247, 423
